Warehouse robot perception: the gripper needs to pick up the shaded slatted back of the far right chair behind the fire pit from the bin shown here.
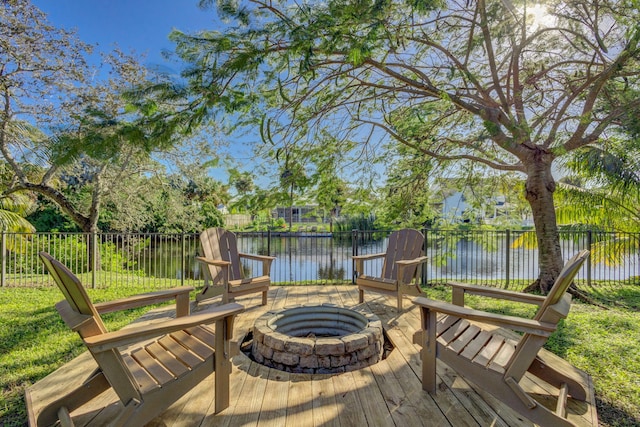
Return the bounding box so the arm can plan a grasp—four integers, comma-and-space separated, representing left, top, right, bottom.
382, 229, 424, 283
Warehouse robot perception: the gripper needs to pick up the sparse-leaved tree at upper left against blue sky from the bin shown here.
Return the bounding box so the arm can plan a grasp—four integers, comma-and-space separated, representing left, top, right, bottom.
0, 0, 189, 237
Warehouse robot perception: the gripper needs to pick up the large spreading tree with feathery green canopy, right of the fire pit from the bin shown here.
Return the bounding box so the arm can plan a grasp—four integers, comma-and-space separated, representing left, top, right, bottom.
165, 0, 640, 291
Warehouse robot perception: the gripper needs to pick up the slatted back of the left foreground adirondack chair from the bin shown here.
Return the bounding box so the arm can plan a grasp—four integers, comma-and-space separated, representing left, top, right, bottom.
39, 252, 107, 336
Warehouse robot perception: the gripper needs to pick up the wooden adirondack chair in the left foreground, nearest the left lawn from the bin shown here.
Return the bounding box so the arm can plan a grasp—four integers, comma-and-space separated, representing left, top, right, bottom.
36, 252, 243, 426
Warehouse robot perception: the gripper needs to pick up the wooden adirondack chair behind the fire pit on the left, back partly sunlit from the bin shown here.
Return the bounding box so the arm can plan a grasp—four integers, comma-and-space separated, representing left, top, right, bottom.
196, 228, 275, 305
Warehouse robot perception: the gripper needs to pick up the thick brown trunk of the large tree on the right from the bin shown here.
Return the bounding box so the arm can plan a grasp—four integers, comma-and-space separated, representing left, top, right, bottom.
525, 155, 564, 294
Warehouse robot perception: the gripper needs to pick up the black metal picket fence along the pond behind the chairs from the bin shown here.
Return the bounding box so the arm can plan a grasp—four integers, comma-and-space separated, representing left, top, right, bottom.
0, 229, 640, 289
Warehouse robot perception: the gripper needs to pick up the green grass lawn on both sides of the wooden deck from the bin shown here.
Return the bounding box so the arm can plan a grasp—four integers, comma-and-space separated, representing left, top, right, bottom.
0, 285, 640, 426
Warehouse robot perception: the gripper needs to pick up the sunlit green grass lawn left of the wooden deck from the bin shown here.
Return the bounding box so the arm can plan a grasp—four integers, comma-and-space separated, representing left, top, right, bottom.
0, 287, 180, 427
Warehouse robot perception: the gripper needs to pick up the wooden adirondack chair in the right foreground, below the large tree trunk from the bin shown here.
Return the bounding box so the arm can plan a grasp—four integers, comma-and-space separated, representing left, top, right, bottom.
413, 250, 589, 427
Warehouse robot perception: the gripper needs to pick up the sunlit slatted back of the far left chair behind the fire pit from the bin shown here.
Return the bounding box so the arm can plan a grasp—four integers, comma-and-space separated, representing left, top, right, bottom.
200, 227, 243, 284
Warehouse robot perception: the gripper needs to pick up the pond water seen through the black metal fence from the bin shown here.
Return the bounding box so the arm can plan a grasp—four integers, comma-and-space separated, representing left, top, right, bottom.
141, 234, 620, 284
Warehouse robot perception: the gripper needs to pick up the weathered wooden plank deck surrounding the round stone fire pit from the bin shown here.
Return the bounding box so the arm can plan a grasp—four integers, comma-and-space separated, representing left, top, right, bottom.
27, 286, 598, 427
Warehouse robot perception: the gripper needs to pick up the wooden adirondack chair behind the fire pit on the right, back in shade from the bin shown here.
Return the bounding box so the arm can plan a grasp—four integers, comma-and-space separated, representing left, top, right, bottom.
353, 229, 427, 311
